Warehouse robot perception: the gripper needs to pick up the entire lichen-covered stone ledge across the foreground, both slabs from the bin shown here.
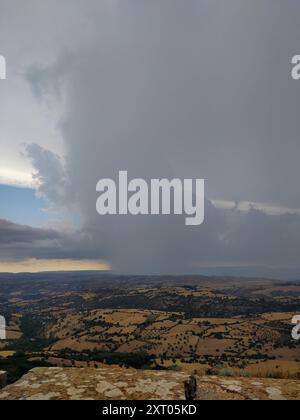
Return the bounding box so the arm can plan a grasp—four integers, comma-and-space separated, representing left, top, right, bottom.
0, 367, 300, 400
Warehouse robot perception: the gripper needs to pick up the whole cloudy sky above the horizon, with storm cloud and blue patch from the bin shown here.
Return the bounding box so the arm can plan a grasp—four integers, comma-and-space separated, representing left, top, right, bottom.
0, 0, 300, 278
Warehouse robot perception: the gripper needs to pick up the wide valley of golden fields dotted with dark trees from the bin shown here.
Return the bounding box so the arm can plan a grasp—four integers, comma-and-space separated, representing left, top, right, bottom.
0, 273, 300, 382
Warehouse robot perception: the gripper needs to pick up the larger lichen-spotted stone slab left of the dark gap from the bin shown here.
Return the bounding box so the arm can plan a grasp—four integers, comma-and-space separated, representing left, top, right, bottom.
0, 367, 189, 400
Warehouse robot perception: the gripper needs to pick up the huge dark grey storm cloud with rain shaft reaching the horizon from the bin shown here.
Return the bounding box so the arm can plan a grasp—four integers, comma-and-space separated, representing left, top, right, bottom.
4, 0, 300, 273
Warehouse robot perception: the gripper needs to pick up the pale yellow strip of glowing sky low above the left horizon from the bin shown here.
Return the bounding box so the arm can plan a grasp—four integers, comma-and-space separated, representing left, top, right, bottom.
0, 258, 111, 274
